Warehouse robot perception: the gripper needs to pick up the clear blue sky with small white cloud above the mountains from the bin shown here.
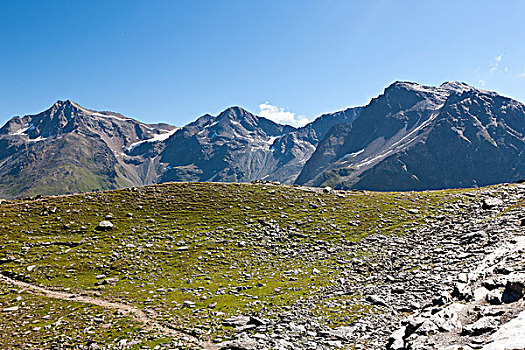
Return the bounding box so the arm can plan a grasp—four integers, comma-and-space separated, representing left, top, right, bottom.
0, 0, 525, 126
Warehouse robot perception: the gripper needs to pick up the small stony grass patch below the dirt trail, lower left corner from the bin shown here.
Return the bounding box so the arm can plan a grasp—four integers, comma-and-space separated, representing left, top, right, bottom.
0, 284, 176, 349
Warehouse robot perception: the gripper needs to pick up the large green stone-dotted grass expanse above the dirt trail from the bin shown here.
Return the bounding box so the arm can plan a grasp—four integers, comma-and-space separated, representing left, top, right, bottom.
0, 183, 472, 342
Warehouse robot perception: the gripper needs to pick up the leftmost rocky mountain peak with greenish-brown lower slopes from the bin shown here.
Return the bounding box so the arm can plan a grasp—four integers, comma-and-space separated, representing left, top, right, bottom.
0, 100, 178, 196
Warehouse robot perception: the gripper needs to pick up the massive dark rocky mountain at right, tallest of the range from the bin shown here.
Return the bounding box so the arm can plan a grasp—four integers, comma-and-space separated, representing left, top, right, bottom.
297, 82, 525, 190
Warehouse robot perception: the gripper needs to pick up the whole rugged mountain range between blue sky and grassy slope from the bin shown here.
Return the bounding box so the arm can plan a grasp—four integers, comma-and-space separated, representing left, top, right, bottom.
0, 82, 525, 198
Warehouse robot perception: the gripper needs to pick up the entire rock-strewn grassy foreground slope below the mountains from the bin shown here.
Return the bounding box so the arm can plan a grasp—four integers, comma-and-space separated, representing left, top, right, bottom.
0, 183, 525, 350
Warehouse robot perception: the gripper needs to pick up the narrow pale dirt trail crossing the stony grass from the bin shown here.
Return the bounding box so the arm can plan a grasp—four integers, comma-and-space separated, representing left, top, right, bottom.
0, 274, 217, 350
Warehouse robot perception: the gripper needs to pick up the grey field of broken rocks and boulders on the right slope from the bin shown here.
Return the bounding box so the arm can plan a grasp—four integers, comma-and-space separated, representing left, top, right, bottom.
217, 185, 525, 350
